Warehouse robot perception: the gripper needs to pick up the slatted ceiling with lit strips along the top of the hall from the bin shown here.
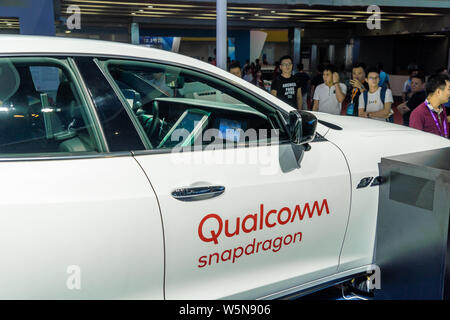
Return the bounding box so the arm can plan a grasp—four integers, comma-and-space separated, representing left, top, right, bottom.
58, 0, 450, 28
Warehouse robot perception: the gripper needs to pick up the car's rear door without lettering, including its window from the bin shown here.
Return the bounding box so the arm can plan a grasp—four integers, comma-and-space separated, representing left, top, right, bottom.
0, 57, 164, 299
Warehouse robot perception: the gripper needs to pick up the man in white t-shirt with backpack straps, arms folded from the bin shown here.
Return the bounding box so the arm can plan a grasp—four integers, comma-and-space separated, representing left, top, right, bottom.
359, 68, 394, 121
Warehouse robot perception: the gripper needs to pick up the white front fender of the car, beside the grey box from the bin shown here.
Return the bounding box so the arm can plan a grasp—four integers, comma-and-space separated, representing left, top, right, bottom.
326, 116, 450, 271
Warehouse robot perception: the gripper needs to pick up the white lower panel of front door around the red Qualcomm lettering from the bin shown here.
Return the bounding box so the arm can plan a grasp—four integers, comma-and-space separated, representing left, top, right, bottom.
136, 141, 350, 299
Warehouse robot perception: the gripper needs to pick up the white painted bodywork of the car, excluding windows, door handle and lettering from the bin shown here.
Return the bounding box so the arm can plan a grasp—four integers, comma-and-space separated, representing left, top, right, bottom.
0, 36, 450, 299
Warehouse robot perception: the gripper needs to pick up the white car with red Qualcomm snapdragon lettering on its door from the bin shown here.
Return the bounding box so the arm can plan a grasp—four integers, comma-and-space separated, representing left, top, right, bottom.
0, 36, 450, 299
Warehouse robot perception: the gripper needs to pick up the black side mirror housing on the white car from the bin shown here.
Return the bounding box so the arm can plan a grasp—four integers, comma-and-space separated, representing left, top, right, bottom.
289, 110, 317, 145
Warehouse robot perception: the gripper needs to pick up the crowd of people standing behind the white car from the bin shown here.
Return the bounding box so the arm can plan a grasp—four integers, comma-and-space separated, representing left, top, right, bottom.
229, 55, 450, 138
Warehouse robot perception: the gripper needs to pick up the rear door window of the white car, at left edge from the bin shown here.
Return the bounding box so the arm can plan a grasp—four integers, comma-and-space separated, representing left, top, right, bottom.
0, 57, 100, 155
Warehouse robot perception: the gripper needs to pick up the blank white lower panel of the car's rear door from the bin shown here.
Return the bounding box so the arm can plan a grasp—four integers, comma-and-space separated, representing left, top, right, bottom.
0, 156, 164, 299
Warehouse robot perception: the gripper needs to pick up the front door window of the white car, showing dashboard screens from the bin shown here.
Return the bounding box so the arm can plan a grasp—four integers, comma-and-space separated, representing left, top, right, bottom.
101, 59, 286, 149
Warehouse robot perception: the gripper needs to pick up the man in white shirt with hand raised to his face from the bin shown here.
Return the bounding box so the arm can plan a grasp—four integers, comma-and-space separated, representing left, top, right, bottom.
313, 65, 347, 115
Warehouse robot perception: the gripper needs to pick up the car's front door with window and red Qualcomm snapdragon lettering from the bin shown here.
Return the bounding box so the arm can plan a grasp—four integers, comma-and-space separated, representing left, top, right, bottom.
101, 59, 350, 299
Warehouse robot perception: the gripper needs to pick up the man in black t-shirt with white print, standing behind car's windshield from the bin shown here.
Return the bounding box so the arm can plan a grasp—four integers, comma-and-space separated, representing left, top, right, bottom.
270, 56, 303, 110
